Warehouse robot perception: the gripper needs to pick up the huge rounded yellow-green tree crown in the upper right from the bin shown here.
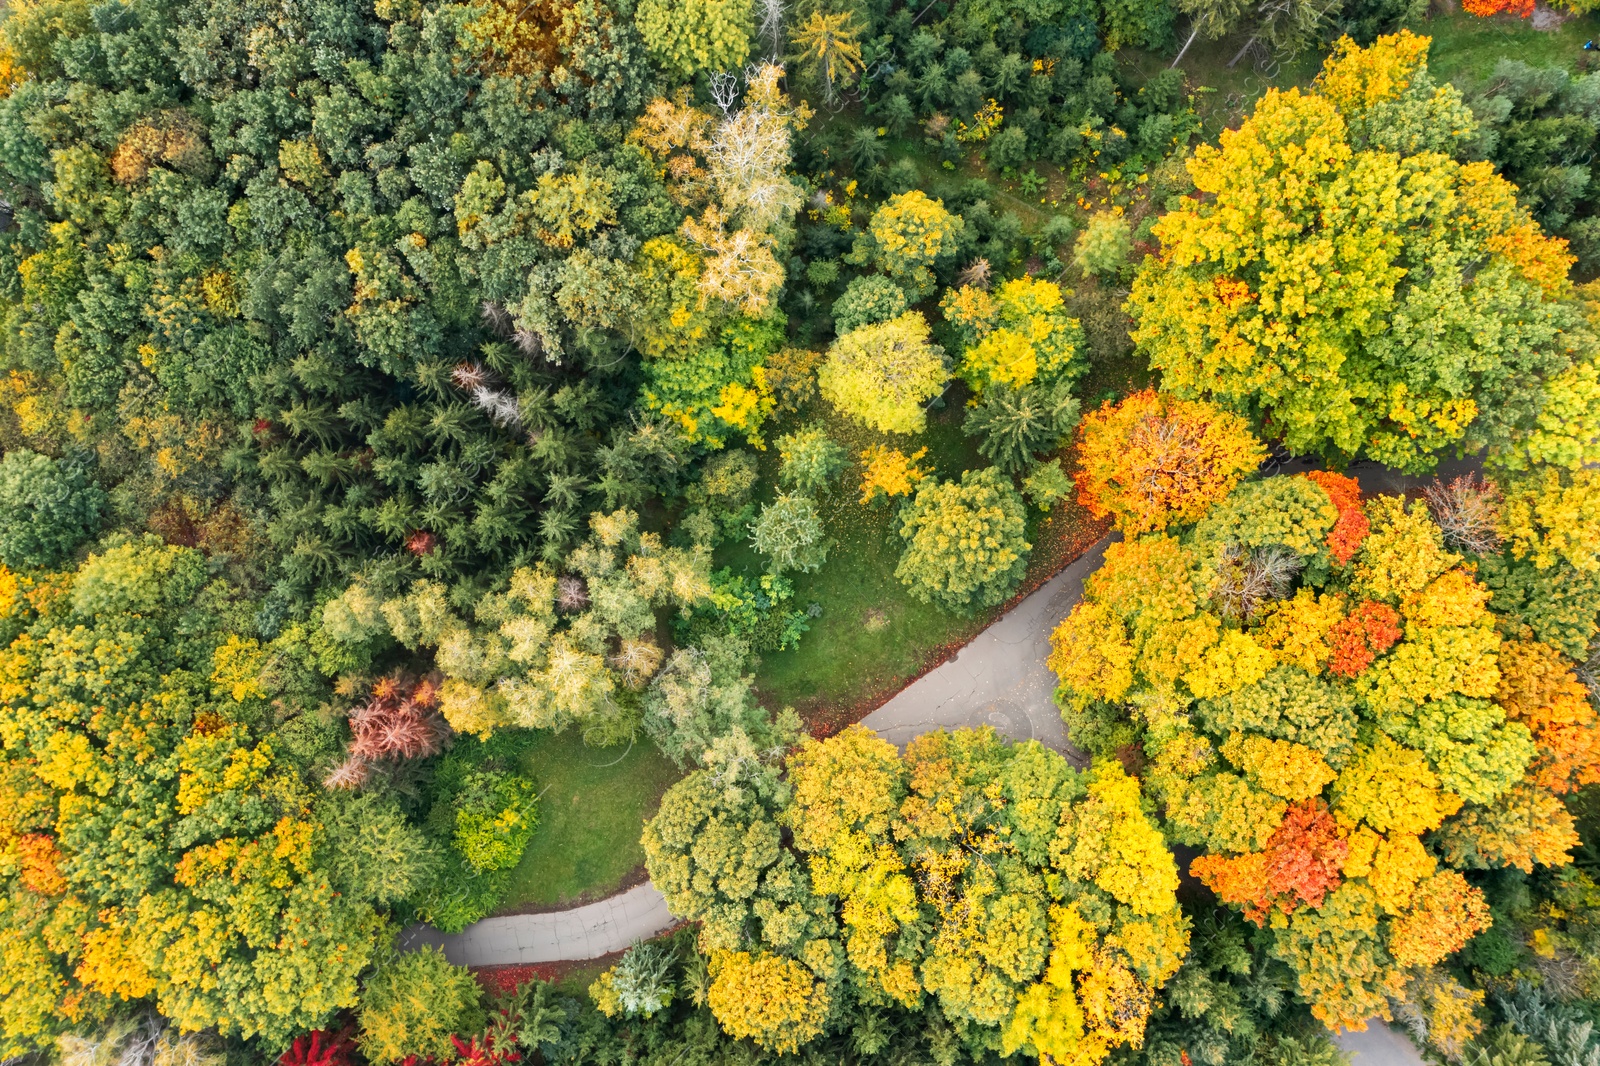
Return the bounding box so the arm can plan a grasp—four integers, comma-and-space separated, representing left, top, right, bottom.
1126, 32, 1581, 471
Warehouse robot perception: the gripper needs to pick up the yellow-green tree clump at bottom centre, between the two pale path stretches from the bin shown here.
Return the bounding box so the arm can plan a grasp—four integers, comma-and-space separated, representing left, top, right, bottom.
645, 727, 1189, 1066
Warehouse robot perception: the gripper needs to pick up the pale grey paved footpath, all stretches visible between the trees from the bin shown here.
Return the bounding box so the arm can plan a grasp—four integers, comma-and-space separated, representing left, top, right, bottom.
400, 461, 1477, 1066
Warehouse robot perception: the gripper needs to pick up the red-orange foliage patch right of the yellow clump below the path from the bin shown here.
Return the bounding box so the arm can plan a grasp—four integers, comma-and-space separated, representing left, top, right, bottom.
1189, 799, 1350, 925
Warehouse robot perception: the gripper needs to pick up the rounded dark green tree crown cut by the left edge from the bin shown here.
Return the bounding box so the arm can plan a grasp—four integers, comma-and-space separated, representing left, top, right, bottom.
0, 448, 106, 568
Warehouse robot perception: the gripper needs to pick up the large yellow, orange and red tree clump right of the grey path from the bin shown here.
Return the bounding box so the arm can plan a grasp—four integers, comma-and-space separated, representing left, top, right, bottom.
1051, 460, 1600, 1043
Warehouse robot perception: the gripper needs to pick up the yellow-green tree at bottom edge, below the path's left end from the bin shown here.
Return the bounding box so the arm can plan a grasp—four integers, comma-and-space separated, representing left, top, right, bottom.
357, 948, 483, 1063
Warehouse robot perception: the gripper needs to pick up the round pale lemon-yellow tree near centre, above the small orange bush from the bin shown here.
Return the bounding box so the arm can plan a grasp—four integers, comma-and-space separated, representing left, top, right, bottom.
818, 311, 950, 434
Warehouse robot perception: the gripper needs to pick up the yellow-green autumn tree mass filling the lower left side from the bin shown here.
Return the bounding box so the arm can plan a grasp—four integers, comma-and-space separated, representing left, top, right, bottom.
0, 538, 382, 1055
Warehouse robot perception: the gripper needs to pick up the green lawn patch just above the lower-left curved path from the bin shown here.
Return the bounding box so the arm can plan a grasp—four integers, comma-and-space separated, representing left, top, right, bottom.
502, 730, 682, 911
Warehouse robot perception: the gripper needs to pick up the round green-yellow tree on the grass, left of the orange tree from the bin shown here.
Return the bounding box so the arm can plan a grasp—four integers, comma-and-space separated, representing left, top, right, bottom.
894, 467, 1032, 613
